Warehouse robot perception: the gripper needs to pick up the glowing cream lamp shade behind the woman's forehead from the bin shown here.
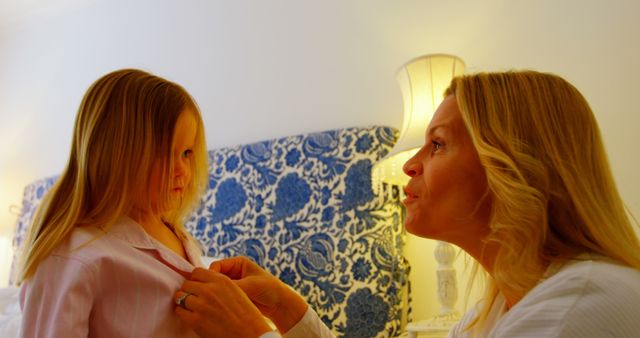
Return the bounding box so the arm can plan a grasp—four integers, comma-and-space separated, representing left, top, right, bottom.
372, 54, 465, 190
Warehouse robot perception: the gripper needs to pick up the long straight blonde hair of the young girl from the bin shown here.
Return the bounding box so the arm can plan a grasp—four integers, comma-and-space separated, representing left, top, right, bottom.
19, 69, 208, 281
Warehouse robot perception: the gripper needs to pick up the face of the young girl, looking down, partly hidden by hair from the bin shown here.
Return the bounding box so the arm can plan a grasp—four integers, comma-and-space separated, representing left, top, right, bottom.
149, 109, 198, 213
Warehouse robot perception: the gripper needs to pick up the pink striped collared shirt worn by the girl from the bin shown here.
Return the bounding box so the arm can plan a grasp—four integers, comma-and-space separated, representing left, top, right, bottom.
20, 217, 202, 338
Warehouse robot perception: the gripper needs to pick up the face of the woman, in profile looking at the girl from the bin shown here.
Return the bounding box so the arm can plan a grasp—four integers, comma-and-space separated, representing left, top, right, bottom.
403, 95, 490, 247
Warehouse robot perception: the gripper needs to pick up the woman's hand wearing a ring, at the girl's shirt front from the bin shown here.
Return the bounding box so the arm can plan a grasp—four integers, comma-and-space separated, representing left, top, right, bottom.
174, 268, 271, 338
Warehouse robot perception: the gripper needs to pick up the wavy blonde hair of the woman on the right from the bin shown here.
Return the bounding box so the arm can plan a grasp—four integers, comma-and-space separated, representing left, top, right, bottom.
445, 71, 640, 327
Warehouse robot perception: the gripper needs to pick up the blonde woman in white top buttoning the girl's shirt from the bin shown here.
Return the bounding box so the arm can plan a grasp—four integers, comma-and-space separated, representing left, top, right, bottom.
174, 71, 640, 338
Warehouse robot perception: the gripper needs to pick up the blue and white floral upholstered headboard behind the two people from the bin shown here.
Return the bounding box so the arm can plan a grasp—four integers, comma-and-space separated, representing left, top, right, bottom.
16, 127, 409, 337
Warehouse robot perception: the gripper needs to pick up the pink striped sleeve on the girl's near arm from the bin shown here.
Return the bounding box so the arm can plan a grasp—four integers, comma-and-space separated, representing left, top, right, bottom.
20, 255, 97, 338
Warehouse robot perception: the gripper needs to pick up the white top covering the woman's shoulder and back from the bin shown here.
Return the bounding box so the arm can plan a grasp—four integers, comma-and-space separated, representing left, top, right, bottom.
448, 259, 640, 338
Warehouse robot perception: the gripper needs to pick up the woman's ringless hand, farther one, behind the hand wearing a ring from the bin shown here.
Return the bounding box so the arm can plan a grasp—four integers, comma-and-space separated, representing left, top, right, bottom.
209, 257, 308, 333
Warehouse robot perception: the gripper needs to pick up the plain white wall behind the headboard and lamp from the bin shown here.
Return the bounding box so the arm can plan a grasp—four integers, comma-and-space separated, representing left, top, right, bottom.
0, 0, 640, 319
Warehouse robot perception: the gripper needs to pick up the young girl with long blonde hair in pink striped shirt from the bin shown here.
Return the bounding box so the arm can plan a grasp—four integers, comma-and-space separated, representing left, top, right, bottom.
20, 69, 207, 337
